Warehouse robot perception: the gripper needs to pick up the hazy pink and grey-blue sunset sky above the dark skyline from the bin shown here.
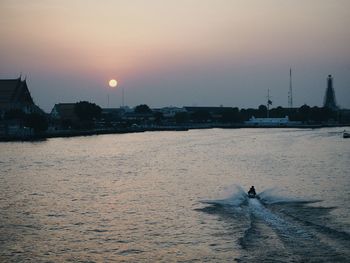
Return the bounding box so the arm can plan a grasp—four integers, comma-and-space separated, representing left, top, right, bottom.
0, 0, 350, 112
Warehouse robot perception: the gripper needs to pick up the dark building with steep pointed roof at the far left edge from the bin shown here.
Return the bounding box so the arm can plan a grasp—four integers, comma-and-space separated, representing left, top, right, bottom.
0, 77, 44, 117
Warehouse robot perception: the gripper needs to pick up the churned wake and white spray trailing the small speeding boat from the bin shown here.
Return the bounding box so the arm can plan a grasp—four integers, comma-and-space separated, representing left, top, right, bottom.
201, 185, 350, 262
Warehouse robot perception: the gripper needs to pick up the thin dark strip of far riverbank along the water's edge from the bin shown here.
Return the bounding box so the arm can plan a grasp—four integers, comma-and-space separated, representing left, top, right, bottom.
0, 123, 350, 142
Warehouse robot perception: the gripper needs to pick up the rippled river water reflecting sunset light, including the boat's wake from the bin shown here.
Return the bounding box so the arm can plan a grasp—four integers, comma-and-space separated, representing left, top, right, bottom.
0, 128, 350, 262
